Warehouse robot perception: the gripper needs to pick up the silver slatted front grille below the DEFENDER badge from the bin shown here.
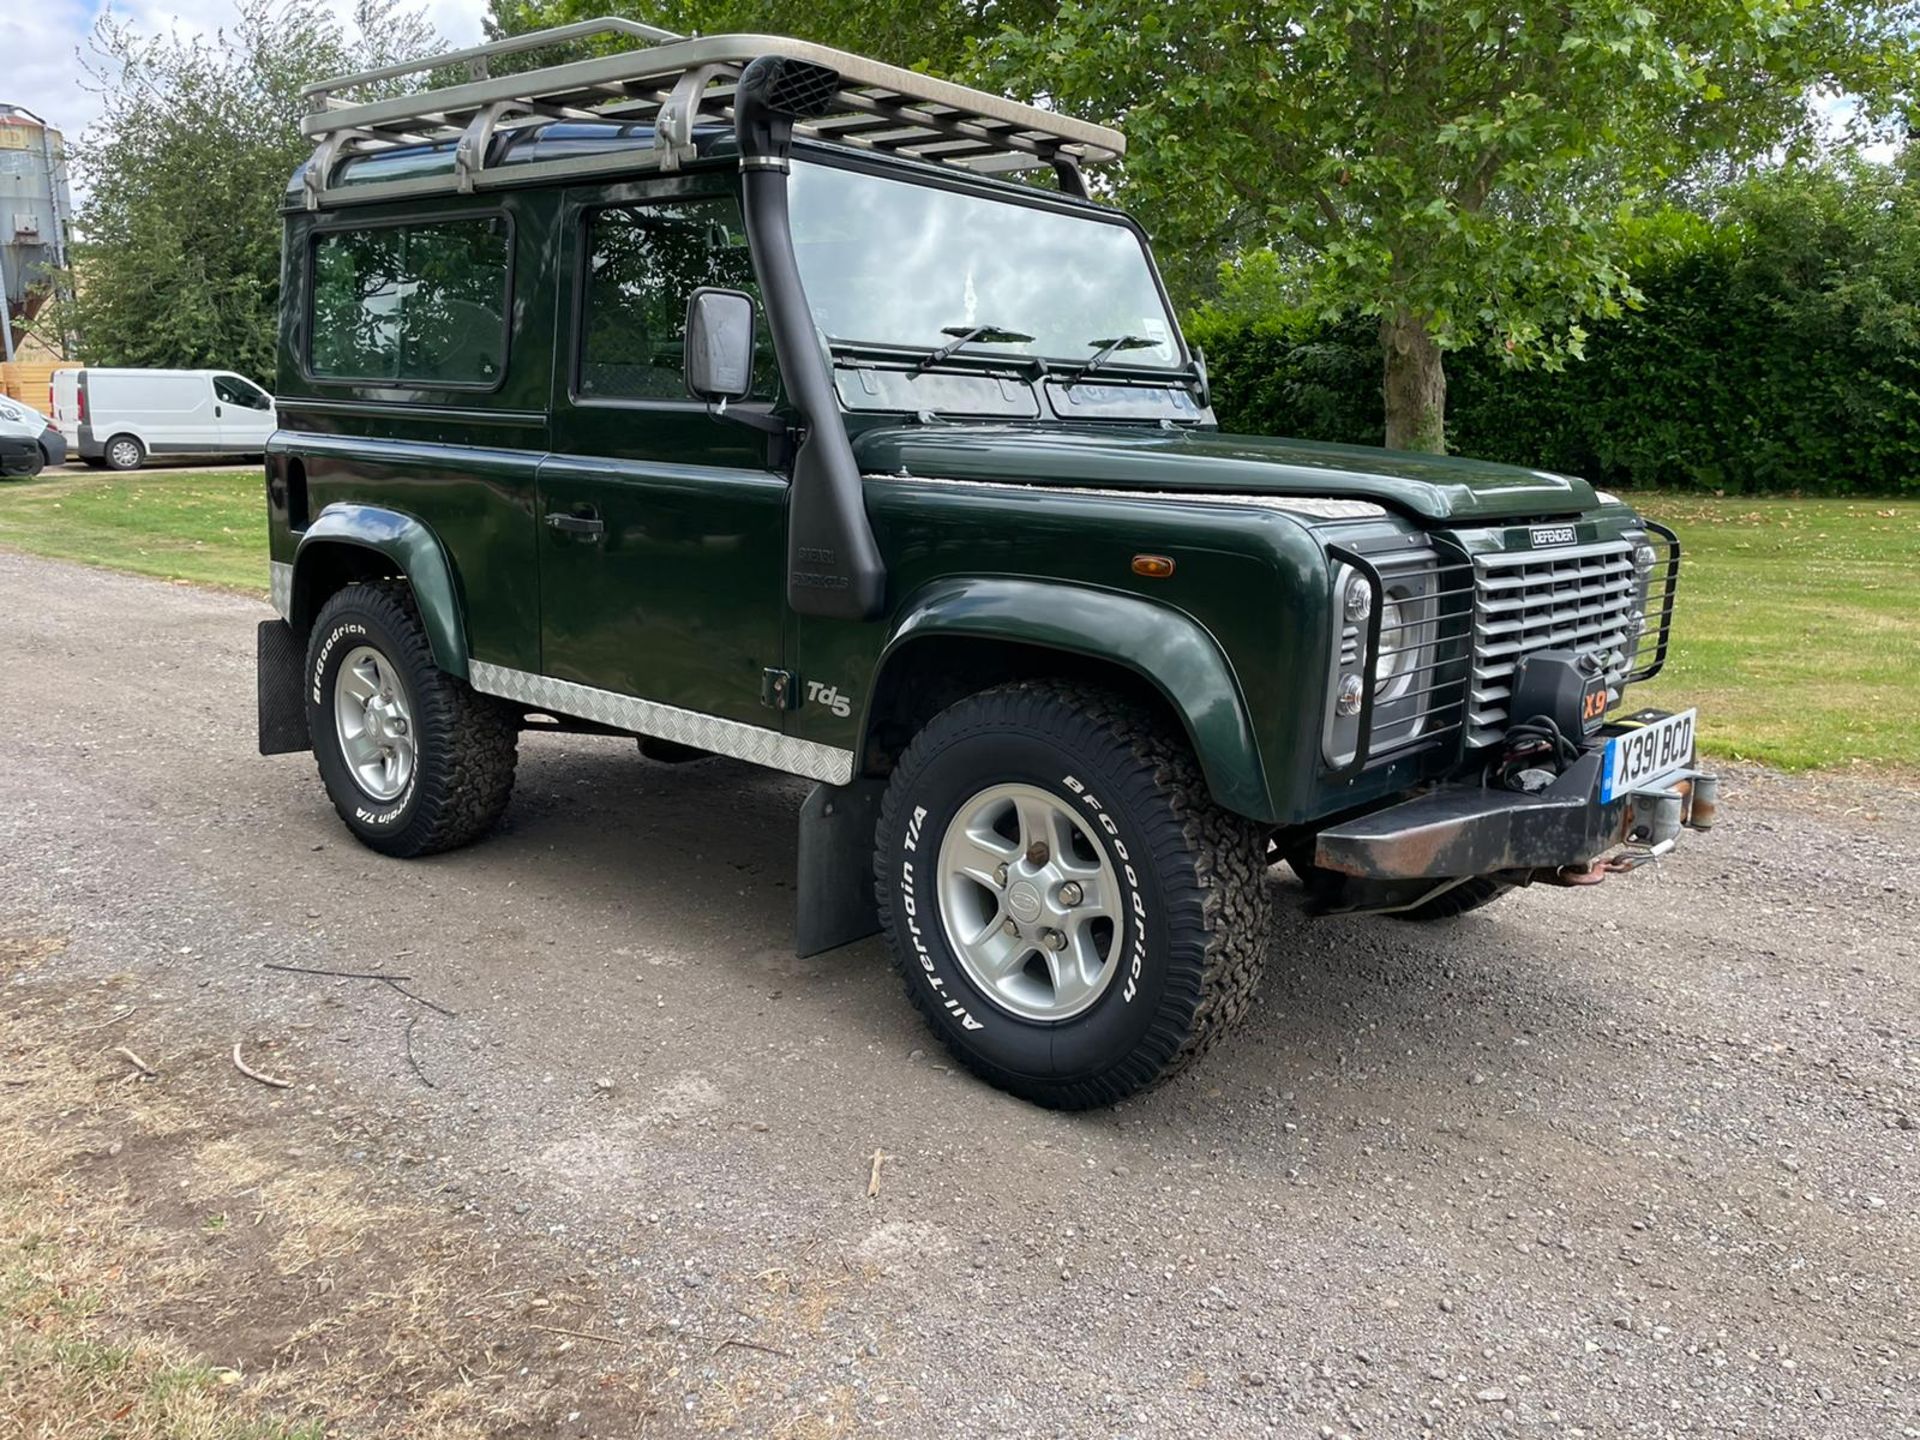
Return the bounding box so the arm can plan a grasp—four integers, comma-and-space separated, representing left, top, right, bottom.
1467, 536, 1642, 747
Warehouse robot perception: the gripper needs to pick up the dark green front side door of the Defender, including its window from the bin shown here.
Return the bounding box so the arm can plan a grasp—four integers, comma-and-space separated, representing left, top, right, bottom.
540, 180, 787, 733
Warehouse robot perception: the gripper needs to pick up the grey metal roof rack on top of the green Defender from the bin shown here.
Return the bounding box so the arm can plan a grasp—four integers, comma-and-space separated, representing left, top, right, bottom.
300, 19, 1127, 209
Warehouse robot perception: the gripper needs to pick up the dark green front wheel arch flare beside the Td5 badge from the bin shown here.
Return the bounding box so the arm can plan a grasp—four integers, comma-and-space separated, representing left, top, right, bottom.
860, 578, 1273, 820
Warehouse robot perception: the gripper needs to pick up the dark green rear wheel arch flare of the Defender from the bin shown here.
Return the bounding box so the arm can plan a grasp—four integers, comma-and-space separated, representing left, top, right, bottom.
286, 503, 467, 680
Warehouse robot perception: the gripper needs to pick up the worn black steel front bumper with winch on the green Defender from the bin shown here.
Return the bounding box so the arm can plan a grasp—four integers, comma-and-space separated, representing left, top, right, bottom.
1313, 747, 1718, 879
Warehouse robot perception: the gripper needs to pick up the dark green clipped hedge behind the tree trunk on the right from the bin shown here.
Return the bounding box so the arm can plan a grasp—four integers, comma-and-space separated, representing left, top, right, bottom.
1190, 165, 1920, 495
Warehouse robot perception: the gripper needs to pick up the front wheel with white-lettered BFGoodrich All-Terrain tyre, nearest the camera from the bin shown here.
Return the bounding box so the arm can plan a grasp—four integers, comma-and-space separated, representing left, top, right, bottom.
876, 682, 1271, 1110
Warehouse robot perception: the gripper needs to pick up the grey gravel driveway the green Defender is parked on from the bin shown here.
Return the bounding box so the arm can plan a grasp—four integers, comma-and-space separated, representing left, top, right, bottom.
0, 555, 1920, 1438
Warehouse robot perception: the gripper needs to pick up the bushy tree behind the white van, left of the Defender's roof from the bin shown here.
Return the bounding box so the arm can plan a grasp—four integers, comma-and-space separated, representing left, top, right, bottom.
73, 0, 440, 380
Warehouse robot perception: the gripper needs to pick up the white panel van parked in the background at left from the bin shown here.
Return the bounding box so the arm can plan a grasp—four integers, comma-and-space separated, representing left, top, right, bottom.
50, 367, 278, 470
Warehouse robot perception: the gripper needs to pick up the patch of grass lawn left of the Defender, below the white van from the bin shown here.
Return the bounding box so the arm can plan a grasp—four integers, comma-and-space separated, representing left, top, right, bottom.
0, 468, 267, 595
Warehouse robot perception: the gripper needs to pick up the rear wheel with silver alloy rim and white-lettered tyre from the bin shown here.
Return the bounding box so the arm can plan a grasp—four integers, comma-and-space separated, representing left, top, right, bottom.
303, 582, 518, 858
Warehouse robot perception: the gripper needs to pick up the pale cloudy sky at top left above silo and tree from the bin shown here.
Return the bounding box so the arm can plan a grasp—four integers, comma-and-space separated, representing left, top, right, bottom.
0, 0, 486, 157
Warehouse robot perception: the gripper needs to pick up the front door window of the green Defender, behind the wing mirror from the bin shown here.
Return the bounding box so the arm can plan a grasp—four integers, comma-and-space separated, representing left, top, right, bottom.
576, 196, 776, 399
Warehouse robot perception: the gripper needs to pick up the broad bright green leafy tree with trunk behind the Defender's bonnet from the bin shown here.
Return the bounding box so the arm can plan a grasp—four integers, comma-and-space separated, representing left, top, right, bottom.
979, 0, 1916, 451
